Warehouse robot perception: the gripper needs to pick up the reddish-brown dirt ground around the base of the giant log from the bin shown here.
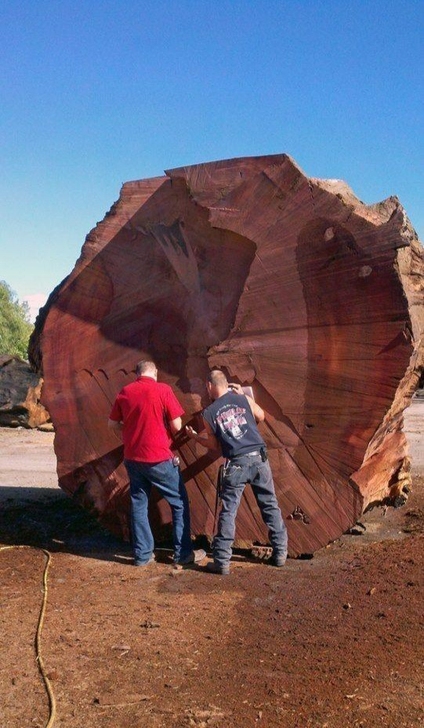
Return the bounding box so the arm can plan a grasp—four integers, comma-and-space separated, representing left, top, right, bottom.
0, 401, 424, 728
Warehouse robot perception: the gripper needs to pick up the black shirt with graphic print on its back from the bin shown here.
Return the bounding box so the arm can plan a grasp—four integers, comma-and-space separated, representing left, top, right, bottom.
202, 391, 265, 458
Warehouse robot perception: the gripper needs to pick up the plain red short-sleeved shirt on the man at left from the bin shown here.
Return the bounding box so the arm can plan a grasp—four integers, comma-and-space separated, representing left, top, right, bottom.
109, 376, 184, 463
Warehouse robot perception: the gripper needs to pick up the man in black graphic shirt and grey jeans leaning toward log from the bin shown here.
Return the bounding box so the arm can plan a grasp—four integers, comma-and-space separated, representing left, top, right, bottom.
186, 369, 287, 574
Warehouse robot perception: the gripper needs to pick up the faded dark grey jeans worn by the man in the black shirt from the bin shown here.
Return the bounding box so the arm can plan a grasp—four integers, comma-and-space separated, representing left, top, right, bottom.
213, 455, 287, 566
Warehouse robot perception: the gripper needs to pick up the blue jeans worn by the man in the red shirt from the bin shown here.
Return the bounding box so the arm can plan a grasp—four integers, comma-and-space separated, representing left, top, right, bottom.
124, 460, 193, 564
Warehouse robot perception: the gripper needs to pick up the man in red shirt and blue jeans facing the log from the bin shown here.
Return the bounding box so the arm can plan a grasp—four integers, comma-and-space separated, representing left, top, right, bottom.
108, 361, 206, 566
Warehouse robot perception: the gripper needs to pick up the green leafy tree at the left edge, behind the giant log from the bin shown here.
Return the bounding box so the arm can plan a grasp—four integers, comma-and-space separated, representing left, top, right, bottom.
0, 281, 34, 359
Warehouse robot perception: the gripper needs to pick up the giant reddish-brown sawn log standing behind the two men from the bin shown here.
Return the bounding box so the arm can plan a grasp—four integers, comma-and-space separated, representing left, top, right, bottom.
31, 155, 424, 556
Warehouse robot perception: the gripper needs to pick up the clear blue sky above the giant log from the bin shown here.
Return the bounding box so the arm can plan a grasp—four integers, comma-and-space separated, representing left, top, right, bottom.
0, 0, 424, 318
